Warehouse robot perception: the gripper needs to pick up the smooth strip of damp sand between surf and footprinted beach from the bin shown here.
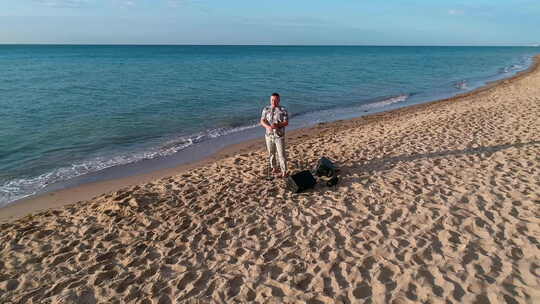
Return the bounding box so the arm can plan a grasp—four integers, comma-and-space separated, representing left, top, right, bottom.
0, 55, 540, 223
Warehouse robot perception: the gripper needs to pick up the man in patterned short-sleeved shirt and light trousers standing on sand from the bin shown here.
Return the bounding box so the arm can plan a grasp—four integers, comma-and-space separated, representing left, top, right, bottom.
261, 93, 289, 177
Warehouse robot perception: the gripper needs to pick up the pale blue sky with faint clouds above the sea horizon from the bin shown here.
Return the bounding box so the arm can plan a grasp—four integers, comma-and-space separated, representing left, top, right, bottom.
0, 0, 540, 45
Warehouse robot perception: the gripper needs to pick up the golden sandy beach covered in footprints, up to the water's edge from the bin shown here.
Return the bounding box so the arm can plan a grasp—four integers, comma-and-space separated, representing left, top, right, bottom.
0, 58, 540, 303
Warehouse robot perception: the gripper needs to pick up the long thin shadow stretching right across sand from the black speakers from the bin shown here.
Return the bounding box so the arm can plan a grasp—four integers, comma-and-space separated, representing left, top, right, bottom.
330, 141, 540, 186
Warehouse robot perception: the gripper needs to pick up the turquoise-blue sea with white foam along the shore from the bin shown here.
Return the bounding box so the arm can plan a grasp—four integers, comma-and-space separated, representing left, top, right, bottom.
0, 45, 539, 206
